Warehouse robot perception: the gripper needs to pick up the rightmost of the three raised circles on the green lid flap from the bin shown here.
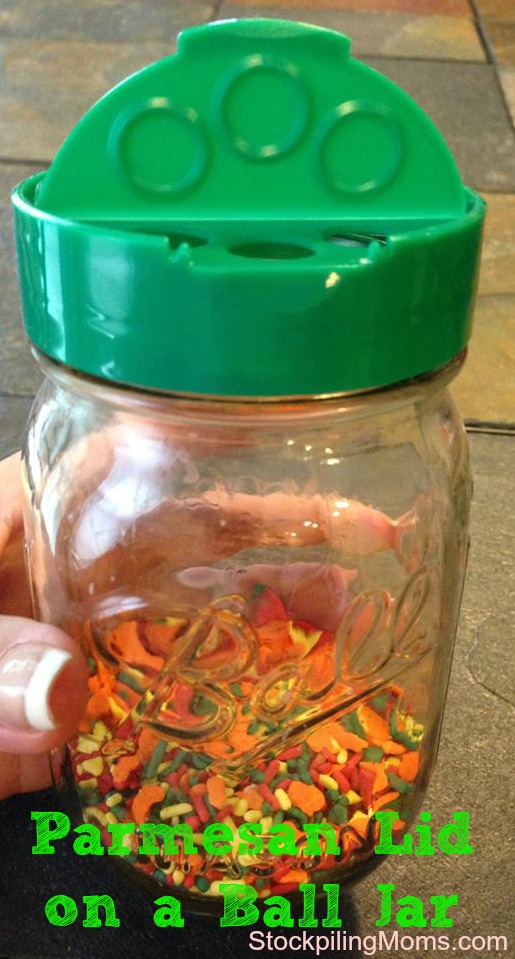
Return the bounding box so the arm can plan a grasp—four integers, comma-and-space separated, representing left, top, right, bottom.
318, 100, 404, 195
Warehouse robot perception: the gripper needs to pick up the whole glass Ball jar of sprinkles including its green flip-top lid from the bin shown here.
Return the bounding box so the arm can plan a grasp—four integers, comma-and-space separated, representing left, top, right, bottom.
14, 13, 484, 911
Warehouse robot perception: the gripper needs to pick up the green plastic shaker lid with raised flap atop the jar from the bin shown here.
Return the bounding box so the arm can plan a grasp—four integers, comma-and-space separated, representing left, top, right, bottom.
13, 19, 484, 397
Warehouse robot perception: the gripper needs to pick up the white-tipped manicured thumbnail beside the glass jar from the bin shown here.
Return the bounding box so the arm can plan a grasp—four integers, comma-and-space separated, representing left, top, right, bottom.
0, 643, 72, 732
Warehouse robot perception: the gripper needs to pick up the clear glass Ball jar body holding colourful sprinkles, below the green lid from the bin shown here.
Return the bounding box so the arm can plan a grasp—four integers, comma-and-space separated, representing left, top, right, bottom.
24, 357, 470, 912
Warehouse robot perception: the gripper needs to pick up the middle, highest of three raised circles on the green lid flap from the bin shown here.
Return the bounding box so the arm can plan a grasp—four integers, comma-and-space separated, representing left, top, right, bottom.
217, 54, 309, 160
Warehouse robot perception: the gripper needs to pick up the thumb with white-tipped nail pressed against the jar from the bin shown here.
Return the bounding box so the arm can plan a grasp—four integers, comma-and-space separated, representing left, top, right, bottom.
0, 616, 88, 754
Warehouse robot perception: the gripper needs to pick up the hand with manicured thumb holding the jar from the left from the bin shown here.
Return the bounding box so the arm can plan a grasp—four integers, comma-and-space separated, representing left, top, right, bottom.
0, 454, 87, 799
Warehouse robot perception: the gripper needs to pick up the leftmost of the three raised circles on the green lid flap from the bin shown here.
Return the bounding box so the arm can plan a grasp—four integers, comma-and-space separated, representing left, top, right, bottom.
109, 97, 207, 194
